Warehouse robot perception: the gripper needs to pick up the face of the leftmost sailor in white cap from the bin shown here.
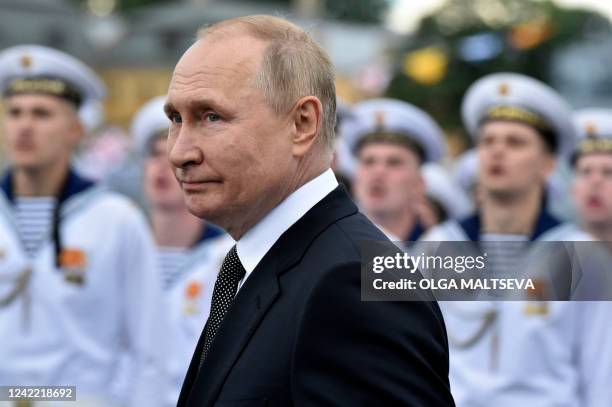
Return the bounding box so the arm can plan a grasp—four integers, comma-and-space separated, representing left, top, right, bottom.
4, 95, 81, 170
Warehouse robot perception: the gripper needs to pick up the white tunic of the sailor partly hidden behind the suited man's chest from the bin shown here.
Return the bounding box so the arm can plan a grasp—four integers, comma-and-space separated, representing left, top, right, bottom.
160, 230, 234, 406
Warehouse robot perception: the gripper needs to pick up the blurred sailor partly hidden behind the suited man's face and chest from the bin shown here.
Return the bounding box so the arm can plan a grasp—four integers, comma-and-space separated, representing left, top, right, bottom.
131, 97, 234, 406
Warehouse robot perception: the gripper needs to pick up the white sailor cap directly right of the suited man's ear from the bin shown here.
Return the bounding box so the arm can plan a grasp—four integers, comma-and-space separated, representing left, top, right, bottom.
340, 99, 446, 162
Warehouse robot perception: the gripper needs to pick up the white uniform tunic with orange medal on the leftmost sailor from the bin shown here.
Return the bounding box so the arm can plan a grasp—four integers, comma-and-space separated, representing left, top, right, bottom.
0, 173, 167, 407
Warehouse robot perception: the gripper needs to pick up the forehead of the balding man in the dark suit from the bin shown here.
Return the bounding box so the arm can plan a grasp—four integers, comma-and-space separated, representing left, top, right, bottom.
168, 34, 266, 103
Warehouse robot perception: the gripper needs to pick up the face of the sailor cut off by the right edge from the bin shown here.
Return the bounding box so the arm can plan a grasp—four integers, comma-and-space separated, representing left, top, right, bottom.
573, 154, 612, 225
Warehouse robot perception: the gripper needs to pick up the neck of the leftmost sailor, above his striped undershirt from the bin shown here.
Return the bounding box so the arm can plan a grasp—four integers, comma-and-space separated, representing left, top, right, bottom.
13, 165, 69, 196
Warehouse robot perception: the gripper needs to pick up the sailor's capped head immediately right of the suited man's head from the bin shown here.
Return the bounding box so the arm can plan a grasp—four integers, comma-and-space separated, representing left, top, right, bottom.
340, 99, 446, 242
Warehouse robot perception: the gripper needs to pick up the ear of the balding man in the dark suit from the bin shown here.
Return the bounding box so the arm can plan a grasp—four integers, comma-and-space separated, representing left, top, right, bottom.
291, 96, 323, 157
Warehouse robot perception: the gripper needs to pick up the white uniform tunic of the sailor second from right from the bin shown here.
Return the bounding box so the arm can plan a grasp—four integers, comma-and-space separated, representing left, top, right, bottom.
424, 212, 612, 407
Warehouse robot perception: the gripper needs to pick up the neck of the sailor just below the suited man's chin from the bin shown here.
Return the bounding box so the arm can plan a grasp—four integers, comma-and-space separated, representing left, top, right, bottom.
151, 209, 204, 249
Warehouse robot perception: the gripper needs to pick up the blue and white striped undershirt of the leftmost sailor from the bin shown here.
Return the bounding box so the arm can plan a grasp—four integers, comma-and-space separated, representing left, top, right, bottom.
15, 196, 57, 257
